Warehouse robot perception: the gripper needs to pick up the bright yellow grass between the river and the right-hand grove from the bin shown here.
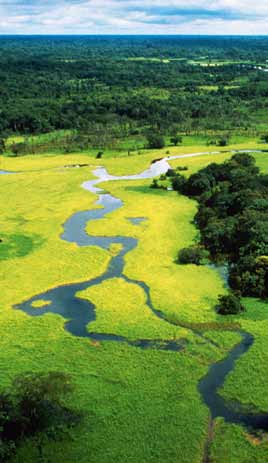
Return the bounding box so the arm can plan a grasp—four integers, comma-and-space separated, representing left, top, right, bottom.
87, 180, 224, 322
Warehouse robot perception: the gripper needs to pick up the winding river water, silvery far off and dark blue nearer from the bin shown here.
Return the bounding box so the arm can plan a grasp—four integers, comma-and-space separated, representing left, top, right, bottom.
3, 150, 268, 436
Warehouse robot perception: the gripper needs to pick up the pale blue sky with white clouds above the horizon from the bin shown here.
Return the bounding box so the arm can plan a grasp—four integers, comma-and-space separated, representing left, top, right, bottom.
0, 0, 268, 35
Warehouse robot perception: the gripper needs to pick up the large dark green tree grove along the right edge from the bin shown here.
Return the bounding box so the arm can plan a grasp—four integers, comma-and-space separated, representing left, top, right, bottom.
173, 153, 268, 298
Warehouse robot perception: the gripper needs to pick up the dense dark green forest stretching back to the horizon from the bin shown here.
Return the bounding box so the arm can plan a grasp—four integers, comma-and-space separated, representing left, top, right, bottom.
0, 36, 268, 150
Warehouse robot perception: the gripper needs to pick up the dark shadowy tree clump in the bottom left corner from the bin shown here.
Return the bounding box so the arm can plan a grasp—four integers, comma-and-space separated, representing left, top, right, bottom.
0, 372, 80, 462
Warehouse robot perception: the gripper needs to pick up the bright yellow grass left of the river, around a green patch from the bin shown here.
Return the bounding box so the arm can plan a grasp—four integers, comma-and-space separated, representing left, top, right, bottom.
0, 170, 110, 316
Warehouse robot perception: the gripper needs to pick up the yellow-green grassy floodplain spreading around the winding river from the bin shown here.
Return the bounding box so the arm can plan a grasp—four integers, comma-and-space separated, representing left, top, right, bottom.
0, 146, 268, 463
